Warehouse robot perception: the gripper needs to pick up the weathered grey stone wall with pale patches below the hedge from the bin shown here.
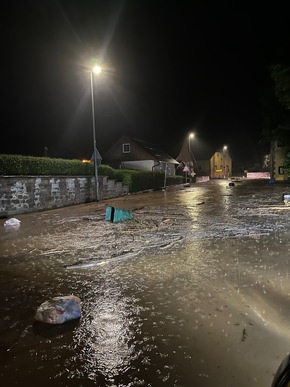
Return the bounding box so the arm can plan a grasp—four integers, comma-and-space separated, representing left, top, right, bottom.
0, 176, 129, 217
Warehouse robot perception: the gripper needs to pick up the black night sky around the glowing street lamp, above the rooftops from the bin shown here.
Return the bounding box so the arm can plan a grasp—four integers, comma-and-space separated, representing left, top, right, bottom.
0, 0, 290, 170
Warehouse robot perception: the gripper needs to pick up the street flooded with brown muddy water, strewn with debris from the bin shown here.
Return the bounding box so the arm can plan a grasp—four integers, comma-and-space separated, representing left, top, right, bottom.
0, 180, 290, 387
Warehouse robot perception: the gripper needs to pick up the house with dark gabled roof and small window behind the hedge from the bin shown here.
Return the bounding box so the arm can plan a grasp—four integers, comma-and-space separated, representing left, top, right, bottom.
103, 135, 179, 176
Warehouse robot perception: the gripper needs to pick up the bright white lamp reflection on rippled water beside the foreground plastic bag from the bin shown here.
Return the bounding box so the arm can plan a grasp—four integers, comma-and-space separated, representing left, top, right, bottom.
71, 287, 137, 383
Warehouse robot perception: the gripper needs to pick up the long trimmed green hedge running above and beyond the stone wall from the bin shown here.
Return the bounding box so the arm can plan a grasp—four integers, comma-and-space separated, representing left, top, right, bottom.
0, 154, 183, 192
